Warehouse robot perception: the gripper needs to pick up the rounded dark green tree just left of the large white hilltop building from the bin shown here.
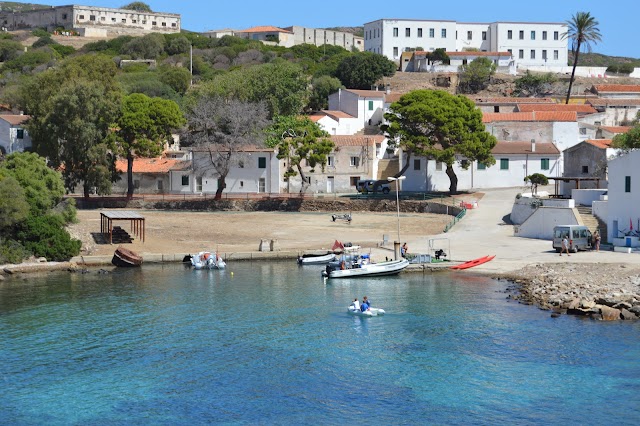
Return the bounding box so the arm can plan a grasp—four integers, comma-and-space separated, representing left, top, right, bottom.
336, 52, 398, 89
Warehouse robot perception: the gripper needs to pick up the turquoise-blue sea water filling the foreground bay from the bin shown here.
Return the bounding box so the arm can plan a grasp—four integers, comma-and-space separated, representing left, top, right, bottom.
0, 261, 640, 425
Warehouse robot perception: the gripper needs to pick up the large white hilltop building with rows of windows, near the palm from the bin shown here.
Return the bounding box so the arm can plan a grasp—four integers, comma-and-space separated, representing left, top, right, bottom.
364, 19, 568, 67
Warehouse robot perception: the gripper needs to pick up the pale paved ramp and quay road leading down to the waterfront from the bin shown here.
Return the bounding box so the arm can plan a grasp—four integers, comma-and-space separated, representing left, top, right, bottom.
402, 188, 640, 272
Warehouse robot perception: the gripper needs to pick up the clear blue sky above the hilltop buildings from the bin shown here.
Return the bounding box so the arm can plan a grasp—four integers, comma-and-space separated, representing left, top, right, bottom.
45, 0, 640, 59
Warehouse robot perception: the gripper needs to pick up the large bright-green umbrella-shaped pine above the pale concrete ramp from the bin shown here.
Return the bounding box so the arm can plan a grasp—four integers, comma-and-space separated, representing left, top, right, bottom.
382, 90, 497, 192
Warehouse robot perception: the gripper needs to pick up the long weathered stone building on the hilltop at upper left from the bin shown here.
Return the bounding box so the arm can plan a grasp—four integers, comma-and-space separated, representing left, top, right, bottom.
0, 5, 181, 37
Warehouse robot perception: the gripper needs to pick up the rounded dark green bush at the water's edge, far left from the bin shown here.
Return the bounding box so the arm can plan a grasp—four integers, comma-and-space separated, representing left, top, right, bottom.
16, 215, 82, 261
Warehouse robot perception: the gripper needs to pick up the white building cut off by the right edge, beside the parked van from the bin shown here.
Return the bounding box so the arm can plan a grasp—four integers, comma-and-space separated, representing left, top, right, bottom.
607, 150, 640, 243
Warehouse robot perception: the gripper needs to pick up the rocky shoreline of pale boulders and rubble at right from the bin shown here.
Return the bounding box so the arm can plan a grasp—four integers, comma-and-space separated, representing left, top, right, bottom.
495, 263, 640, 321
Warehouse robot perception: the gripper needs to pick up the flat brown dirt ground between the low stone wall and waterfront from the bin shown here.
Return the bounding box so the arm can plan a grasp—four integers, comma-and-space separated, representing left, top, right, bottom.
69, 210, 452, 255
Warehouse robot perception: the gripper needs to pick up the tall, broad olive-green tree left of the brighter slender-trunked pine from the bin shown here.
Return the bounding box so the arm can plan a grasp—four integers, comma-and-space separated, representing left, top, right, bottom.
43, 80, 119, 198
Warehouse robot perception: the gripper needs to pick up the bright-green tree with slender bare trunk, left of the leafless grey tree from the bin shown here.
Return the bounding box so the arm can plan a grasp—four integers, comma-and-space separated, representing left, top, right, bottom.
113, 93, 185, 197
